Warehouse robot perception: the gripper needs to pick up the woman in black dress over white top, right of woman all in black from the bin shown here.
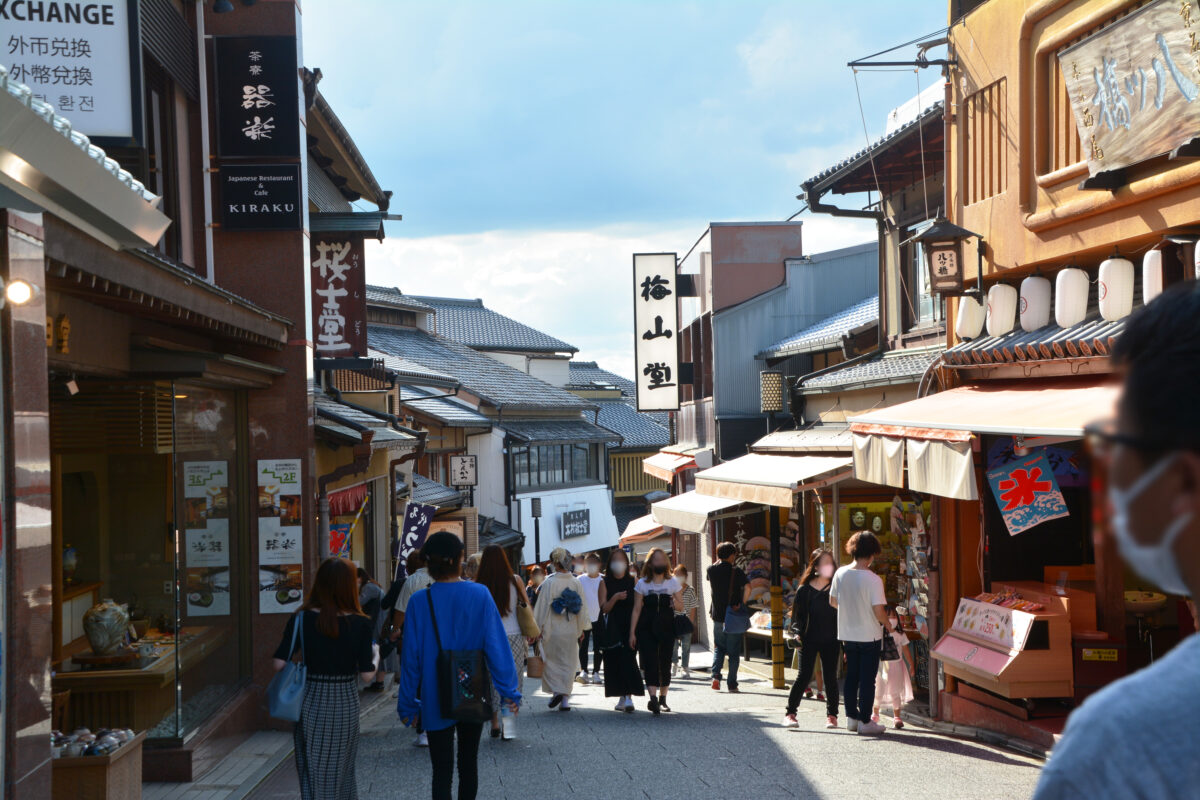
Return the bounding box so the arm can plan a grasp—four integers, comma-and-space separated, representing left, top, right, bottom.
629, 547, 683, 716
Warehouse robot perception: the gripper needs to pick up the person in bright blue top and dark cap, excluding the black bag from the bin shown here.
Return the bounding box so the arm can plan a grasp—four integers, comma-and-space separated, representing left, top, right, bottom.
396, 531, 521, 800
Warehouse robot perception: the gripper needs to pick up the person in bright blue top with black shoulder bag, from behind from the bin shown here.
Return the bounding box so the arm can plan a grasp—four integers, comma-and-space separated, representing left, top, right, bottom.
396, 531, 521, 800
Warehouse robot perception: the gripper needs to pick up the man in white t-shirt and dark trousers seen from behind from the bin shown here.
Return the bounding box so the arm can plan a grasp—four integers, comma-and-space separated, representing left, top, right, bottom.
829, 530, 888, 735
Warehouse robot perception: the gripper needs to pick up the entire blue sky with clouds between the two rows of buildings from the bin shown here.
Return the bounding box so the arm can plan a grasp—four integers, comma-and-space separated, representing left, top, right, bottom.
304, 0, 947, 373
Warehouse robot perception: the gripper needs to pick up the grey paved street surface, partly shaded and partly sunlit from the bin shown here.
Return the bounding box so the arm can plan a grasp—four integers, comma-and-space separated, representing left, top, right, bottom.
251, 673, 1040, 800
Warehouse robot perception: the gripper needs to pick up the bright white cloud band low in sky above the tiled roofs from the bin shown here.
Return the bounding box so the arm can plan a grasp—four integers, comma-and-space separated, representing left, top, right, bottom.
367, 216, 875, 375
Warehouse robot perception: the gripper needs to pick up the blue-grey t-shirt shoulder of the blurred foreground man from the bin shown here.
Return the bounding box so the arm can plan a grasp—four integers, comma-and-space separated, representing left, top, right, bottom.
1033, 633, 1200, 800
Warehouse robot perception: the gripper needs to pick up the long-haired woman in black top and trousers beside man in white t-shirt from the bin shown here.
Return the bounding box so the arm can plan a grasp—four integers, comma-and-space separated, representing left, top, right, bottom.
784, 548, 840, 728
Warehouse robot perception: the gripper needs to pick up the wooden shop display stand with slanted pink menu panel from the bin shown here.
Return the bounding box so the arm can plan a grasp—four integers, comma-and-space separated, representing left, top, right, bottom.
932, 583, 1080, 699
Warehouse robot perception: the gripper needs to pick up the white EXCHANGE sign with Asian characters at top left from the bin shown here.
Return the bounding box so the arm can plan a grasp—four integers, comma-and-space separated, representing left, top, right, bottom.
0, 0, 142, 144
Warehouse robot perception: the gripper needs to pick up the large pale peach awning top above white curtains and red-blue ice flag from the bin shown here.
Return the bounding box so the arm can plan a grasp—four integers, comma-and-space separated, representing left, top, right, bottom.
850, 380, 1117, 441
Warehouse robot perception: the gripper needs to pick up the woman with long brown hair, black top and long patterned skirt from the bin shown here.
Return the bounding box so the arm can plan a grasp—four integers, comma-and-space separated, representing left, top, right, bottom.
275, 558, 376, 800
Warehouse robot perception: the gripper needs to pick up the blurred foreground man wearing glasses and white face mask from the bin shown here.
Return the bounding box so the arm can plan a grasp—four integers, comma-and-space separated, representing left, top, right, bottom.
1033, 287, 1200, 800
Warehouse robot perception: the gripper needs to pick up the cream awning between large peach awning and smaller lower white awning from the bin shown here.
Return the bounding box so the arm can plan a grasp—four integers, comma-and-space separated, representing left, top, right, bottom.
696, 453, 852, 509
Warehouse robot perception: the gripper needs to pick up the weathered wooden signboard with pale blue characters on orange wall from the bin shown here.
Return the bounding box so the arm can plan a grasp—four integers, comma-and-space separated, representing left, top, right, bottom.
1058, 0, 1200, 175
